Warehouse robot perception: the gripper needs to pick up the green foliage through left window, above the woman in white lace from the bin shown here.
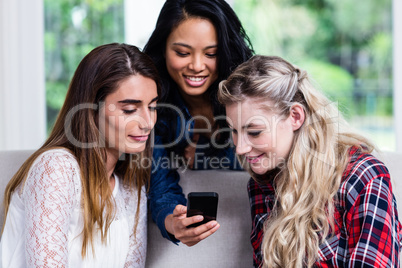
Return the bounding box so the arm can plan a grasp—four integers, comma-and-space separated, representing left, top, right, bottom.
44, 0, 124, 132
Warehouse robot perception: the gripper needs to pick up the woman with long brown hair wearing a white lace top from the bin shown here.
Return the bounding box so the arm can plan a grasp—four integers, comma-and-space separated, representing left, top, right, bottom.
0, 44, 160, 268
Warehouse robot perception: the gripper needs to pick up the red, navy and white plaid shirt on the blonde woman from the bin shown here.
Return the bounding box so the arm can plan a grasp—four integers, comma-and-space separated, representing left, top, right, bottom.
248, 148, 402, 267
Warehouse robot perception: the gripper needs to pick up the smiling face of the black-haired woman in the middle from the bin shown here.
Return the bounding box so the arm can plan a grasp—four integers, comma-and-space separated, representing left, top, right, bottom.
165, 18, 218, 96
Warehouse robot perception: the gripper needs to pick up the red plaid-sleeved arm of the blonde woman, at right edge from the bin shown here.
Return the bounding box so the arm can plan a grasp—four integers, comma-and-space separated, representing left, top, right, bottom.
346, 171, 401, 267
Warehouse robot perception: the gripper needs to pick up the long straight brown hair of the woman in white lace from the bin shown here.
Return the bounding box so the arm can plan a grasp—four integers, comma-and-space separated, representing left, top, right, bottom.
3, 43, 160, 257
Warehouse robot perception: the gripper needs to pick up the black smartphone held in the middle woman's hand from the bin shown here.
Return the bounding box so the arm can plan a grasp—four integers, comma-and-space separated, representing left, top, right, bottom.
187, 192, 219, 228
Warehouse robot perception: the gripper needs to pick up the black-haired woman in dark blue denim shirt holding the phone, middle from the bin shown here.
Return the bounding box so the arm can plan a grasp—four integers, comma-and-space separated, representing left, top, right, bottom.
144, 0, 253, 246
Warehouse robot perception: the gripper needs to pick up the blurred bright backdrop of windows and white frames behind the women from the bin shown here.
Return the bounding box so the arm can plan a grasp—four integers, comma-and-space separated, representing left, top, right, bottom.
0, 0, 402, 151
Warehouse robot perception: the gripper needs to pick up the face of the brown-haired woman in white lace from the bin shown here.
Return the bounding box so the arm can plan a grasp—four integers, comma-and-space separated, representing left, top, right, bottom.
100, 75, 158, 157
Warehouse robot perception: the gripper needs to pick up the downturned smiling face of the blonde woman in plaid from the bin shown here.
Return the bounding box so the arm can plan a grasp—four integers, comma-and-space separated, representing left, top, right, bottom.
226, 99, 300, 175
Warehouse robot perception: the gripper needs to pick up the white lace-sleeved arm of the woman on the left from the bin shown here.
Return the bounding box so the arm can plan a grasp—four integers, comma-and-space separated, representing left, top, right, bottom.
24, 153, 76, 267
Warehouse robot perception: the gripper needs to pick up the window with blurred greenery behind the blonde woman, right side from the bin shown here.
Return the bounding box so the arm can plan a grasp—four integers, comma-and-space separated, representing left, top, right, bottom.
234, 0, 396, 151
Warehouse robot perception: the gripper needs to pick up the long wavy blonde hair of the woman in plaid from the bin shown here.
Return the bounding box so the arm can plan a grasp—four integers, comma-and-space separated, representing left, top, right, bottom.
218, 55, 374, 268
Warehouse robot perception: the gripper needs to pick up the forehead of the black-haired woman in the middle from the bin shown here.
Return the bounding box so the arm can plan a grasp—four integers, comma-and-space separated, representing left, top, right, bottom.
168, 18, 217, 45
